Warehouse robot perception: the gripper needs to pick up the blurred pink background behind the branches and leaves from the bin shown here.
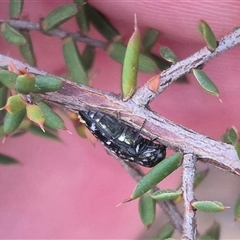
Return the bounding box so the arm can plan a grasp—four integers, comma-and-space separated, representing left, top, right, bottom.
0, 0, 240, 239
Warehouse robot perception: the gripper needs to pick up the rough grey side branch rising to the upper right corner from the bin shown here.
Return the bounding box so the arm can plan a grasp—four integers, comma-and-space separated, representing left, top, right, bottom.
132, 29, 240, 106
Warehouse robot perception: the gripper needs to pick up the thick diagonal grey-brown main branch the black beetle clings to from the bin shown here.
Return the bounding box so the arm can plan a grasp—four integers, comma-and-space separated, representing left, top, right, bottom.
0, 55, 240, 175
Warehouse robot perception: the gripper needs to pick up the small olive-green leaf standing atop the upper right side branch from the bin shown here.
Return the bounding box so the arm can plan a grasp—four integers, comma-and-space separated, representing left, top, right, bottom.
198, 20, 217, 51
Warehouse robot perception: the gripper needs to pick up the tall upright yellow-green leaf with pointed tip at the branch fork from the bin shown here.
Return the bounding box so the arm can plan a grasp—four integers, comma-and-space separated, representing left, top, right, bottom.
122, 15, 141, 101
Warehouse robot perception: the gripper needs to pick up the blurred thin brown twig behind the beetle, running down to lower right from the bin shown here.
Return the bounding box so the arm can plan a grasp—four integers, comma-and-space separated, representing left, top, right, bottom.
120, 160, 183, 233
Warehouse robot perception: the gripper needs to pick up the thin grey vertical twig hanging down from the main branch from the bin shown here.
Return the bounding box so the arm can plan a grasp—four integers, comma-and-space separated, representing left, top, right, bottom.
182, 154, 197, 240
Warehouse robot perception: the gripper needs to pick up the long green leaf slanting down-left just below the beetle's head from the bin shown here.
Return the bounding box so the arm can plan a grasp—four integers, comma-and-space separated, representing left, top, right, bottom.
130, 153, 182, 200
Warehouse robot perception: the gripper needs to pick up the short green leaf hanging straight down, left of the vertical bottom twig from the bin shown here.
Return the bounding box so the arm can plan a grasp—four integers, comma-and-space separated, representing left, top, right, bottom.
138, 194, 156, 227
